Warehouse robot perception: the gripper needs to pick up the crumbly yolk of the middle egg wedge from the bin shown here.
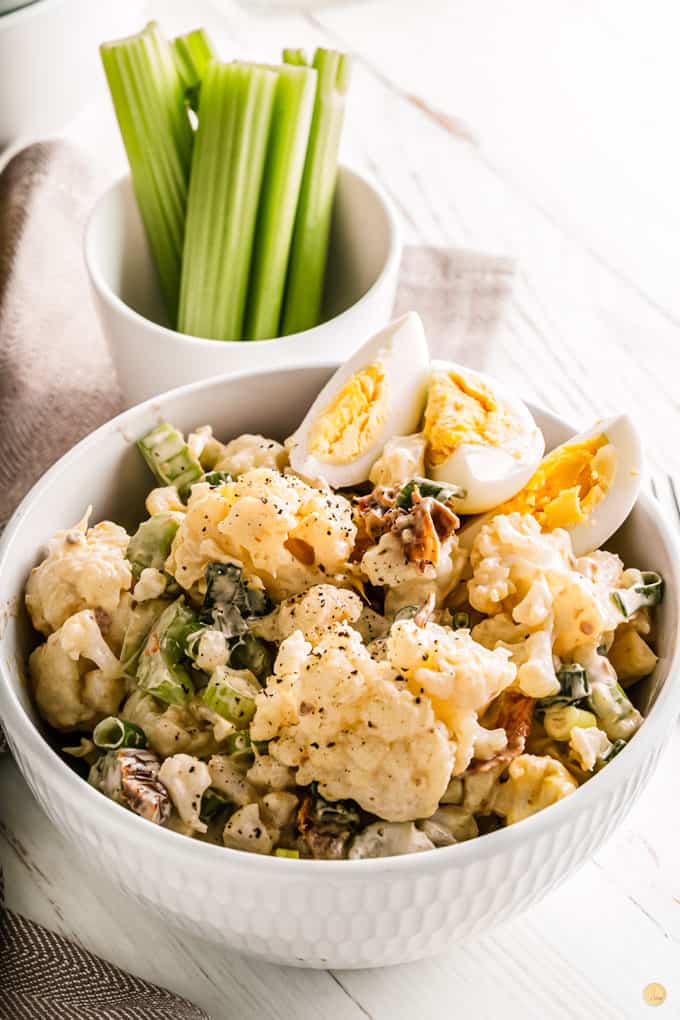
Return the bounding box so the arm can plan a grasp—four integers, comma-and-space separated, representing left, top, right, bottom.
423, 372, 518, 466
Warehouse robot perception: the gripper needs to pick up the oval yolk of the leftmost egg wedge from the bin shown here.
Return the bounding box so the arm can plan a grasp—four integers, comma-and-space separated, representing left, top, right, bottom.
308, 361, 387, 464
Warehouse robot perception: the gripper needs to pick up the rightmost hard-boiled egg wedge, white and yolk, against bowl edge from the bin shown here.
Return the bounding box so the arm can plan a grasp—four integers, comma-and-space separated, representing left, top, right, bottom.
460, 414, 642, 556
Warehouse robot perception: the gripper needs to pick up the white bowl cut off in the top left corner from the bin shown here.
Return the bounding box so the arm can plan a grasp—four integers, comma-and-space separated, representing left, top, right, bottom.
0, 0, 144, 151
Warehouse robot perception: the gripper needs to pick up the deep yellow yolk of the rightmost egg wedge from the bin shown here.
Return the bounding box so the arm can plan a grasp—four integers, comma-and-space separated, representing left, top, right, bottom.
496, 434, 617, 531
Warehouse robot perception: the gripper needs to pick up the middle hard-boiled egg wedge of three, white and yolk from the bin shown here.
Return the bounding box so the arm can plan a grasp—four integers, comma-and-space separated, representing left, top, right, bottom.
423, 363, 544, 514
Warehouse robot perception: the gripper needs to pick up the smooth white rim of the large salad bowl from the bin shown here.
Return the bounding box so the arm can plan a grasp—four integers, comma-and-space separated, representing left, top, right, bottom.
0, 360, 680, 880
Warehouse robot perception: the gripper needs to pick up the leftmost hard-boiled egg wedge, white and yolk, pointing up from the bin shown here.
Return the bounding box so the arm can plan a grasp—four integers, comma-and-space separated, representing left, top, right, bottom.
286, 312, 429, 489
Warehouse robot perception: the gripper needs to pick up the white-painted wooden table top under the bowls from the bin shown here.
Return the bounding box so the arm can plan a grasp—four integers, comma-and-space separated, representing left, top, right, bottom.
0, 0, 680, 1020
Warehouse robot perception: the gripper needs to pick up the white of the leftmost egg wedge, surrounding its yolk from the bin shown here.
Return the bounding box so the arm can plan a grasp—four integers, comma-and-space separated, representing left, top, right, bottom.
285, 312, 429, 489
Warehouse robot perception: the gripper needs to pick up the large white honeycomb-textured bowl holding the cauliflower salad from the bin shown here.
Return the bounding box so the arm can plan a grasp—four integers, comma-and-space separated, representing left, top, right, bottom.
0, 365, 680, 967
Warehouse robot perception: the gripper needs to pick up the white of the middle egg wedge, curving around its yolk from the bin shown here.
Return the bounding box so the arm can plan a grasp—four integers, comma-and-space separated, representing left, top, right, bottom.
427, 362, 545, 514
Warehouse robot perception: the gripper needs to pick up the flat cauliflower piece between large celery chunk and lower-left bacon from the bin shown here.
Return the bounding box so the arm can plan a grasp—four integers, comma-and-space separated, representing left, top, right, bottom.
120, 689, 227, 758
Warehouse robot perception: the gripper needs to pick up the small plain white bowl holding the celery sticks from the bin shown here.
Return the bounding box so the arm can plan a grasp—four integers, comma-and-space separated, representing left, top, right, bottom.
85, 166, 402, 405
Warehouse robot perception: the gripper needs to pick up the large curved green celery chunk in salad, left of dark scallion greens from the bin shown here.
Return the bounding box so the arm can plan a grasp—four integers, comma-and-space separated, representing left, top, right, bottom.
137, 599, 201, 705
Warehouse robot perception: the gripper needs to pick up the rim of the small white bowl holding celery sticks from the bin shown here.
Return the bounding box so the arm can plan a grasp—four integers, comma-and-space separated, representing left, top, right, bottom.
83, 162, 404, 354
